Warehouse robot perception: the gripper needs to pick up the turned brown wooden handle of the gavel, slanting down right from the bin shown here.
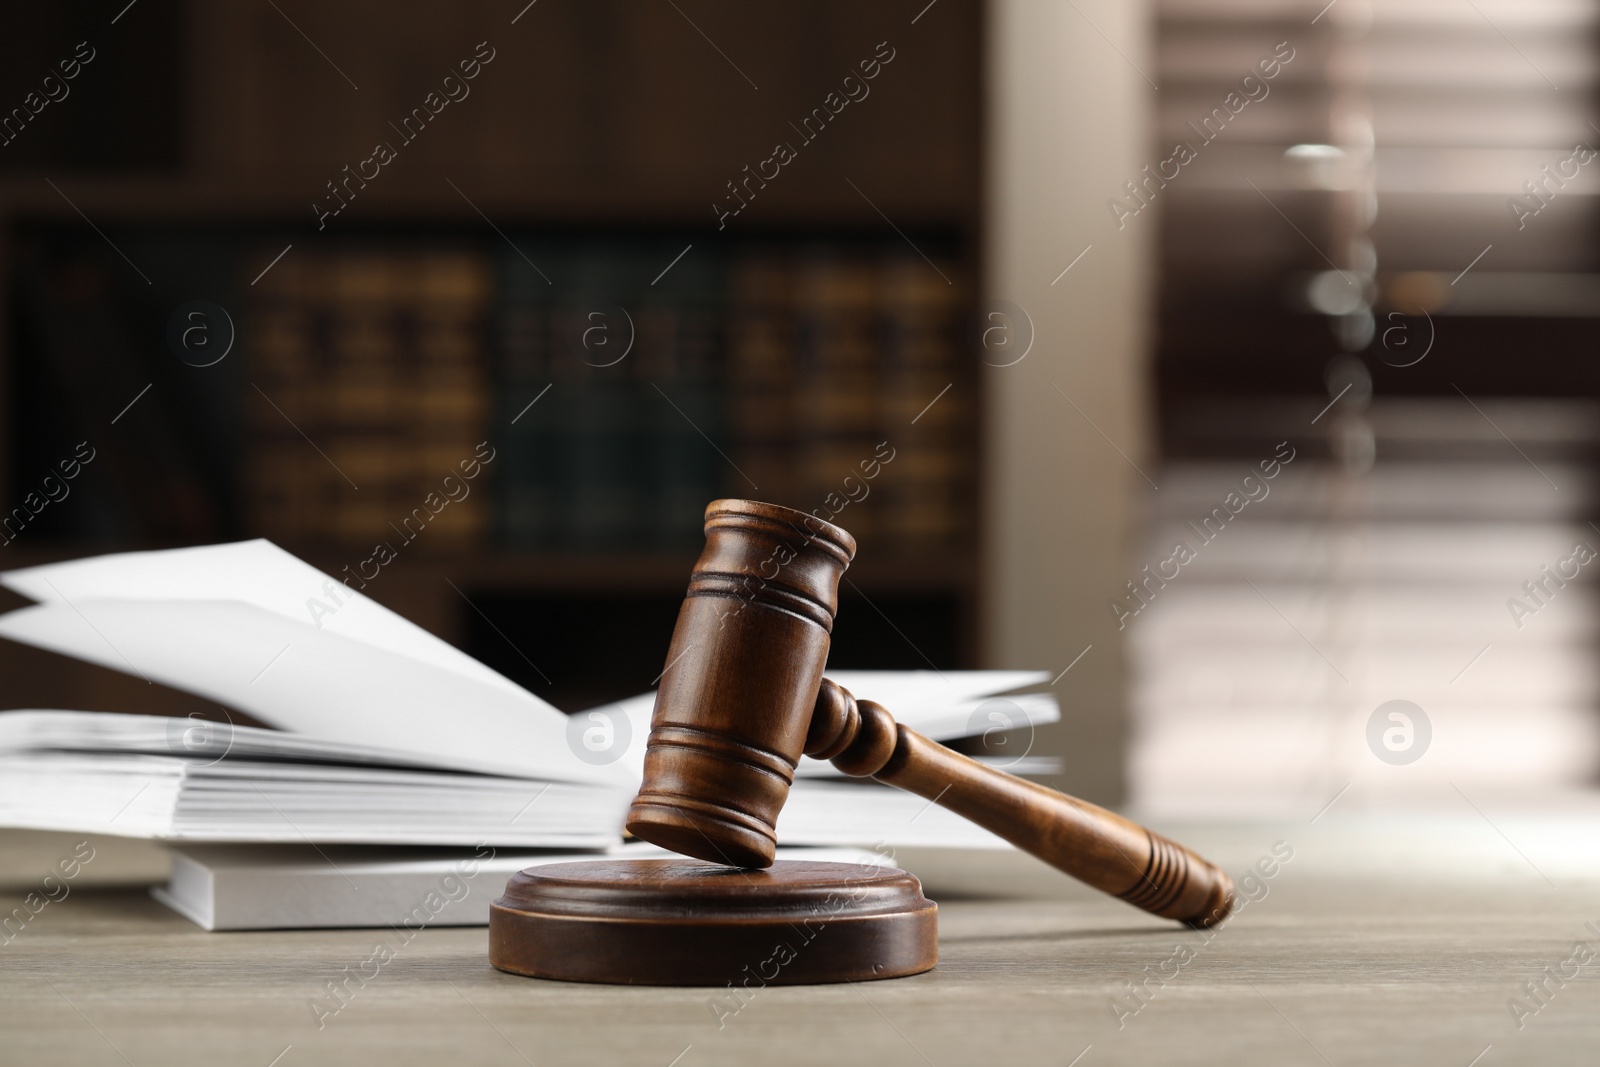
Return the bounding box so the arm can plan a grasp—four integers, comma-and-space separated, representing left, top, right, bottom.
808, 681, 1234, 928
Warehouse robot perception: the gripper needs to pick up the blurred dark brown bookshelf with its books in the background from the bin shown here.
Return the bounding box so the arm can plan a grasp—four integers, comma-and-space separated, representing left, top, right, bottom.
0, 0, 981, 709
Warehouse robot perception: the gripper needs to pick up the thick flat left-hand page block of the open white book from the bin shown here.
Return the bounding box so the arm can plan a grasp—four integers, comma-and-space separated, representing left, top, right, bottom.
0, 710, 626, 848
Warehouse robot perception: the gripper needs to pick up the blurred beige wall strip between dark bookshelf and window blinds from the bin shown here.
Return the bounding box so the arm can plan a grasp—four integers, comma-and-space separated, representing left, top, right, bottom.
982, 0, 1157, 803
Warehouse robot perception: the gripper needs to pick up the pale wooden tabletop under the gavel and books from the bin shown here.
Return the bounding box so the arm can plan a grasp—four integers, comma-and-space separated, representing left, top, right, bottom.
0, 816, 1600, 1067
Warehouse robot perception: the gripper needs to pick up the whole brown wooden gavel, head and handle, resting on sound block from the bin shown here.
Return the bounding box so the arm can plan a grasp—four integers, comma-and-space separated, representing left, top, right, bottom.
627, 501, 1234, 926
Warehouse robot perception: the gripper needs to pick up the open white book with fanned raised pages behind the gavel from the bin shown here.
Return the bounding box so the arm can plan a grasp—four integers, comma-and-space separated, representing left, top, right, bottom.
0, 541, 1059, 849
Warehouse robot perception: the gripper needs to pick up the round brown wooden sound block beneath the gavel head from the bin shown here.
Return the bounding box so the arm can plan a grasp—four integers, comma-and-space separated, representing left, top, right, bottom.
490, 859, 939, 989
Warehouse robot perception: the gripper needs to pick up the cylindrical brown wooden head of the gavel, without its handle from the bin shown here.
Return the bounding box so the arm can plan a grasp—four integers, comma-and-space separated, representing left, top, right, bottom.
627, 501, 856, 867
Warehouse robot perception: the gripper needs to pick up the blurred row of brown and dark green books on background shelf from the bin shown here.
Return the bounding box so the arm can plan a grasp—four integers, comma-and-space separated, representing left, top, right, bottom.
15, 237, 974, 552
